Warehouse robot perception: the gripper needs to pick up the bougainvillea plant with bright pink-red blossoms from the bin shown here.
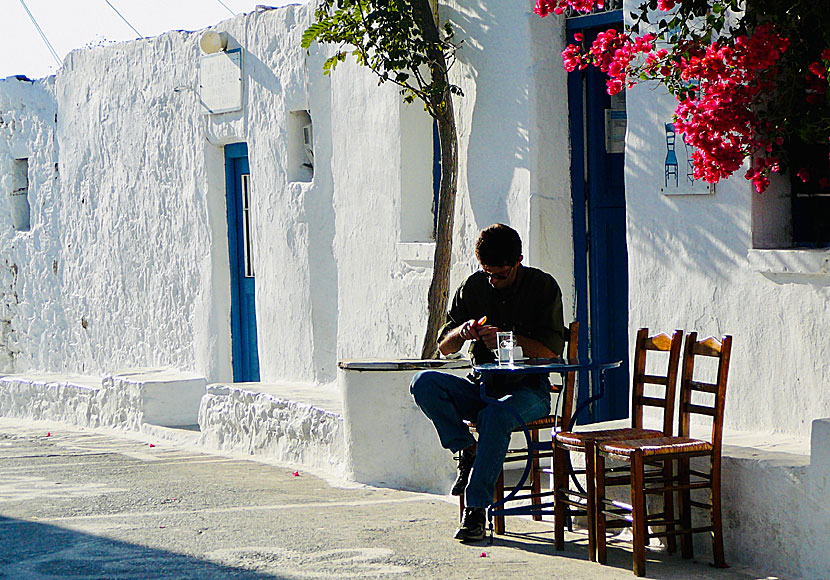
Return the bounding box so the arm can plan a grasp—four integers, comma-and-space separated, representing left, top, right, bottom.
535, 0, 830, 192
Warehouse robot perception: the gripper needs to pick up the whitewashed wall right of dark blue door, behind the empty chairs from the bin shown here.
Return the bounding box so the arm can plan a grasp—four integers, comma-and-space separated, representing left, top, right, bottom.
625, 81, 830, 437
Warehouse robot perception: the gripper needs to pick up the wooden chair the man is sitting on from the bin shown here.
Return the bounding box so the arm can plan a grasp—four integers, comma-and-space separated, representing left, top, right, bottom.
459, 321, 579, 534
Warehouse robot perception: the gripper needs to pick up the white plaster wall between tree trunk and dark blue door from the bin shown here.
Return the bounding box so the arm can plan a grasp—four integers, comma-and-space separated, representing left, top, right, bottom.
446, 0, 574, 318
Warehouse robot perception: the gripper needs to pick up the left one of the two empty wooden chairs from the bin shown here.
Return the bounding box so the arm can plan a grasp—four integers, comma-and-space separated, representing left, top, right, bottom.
553, 328, 683, 562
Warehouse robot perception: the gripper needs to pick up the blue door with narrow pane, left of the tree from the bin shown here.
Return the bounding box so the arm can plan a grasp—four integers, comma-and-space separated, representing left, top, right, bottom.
225, 143, 259, 382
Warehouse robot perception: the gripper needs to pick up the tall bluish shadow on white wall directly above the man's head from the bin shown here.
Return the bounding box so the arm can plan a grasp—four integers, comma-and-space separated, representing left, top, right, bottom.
442, 1, 530, 224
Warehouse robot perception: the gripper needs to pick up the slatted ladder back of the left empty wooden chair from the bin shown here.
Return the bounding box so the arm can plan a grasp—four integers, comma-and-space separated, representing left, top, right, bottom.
631, 328, 683, 435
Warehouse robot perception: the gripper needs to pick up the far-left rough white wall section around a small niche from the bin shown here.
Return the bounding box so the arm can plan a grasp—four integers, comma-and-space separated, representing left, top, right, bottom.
0, 77, 64, 372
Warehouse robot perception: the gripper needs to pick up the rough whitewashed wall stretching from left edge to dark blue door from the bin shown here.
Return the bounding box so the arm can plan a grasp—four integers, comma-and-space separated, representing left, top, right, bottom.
0, 0, 573, 382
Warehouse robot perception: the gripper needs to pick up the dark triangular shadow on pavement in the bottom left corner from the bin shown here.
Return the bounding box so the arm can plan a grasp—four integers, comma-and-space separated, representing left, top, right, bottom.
0, 517, 295, 580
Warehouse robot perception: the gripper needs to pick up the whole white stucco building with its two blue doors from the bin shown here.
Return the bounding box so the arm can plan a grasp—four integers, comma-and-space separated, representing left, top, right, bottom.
0, 0, 830, 577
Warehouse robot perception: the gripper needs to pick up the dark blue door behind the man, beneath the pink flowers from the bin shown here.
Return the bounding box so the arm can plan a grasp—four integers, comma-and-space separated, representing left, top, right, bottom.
568, 10, 629, 424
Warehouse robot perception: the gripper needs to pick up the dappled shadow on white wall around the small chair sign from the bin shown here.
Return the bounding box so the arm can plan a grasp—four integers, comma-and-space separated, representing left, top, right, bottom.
625, 103, 752, 280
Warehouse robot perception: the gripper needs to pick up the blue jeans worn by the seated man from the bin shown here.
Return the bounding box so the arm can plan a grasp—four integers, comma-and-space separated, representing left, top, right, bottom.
409, 371, 550, 508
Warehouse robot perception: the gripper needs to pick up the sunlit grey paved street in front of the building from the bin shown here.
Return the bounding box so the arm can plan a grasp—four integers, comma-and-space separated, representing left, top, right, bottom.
0, 419, 788, 580
